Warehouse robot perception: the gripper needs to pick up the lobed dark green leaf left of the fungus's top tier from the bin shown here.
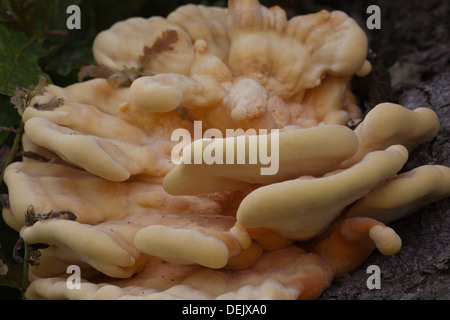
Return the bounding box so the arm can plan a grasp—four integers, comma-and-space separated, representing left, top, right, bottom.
0, 26, 48, 96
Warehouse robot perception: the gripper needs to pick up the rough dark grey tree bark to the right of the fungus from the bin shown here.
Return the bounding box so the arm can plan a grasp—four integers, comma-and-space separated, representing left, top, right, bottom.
321, 0, 450, 300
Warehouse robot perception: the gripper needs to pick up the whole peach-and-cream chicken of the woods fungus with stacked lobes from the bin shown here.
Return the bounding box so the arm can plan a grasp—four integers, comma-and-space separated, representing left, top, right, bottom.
3, 0, 450, 299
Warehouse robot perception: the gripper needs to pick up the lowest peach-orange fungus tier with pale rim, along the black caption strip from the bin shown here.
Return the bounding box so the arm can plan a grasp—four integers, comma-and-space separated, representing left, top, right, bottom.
26, 246, 334, 300
